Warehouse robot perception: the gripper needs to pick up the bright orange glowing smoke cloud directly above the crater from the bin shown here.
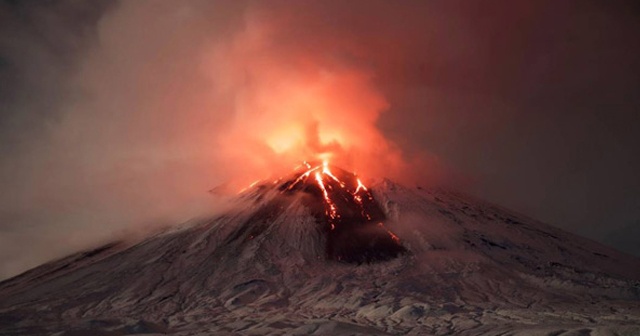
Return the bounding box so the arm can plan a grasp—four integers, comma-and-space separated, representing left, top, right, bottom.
203, 7, 401, 186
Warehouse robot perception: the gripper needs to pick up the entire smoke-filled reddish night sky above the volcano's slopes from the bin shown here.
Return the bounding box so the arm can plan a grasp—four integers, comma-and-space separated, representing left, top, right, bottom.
0, 0, 640, 279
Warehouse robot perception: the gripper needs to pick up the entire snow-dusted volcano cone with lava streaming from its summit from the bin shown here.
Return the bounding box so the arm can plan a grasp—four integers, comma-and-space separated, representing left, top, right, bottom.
0, 163, 640, 335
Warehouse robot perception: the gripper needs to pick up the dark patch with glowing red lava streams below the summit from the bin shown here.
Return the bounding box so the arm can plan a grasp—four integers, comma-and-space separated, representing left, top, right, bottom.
280, 161, 406, 263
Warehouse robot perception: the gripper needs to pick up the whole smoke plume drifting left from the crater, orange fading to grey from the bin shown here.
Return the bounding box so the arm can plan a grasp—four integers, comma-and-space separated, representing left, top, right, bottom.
2, 1, 436, 276
